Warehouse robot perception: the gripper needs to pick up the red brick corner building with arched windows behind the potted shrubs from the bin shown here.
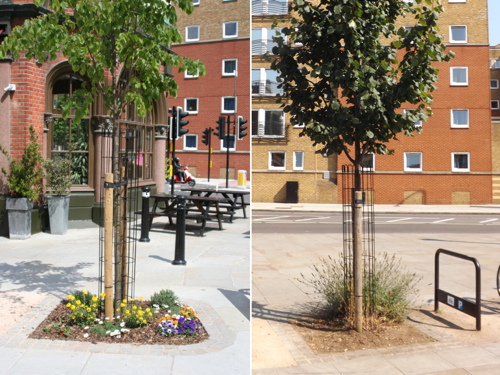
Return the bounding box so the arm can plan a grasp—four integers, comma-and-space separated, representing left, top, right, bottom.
0, 0, 182, 234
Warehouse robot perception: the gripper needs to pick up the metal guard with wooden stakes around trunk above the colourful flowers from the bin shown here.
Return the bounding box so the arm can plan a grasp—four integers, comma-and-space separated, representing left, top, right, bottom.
96, 122, 141, 318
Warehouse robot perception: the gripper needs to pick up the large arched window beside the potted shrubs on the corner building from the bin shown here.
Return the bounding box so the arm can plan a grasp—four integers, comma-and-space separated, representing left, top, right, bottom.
47, 72, 92, 187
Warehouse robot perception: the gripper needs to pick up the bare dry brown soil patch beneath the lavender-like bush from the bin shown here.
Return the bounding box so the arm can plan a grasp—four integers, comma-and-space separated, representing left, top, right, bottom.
290, 317, 435, 354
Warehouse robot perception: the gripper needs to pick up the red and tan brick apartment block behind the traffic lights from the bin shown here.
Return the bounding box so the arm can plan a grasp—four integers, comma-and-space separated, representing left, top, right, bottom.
169, 0, 251, 179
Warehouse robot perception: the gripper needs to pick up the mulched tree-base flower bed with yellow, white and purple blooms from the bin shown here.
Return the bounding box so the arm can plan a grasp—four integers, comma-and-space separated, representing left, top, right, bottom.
29, 291, 208, 345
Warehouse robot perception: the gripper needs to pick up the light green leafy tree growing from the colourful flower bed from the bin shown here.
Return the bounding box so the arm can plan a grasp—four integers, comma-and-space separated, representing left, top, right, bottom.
0, 0, 205, 316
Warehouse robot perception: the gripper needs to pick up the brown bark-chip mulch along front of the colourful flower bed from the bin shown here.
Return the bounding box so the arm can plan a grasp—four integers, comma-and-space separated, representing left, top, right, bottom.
29, 301, 208, 345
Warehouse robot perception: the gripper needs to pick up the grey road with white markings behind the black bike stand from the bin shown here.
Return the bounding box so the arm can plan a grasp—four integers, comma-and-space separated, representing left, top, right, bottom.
252, 211, 500, 234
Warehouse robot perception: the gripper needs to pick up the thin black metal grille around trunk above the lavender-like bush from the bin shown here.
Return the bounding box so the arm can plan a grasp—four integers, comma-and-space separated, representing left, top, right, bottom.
341, 165, 375, 316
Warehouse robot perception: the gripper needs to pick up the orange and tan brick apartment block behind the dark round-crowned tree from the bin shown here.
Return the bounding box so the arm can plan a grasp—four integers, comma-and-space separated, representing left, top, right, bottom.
252, 0, 493, 204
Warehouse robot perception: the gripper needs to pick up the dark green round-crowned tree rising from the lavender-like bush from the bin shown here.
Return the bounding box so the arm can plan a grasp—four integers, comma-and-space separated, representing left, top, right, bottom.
271, 0, 453, 330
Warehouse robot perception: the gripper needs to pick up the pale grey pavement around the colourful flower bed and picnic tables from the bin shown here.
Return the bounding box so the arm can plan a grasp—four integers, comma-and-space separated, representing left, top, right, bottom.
0, 181, 251, 375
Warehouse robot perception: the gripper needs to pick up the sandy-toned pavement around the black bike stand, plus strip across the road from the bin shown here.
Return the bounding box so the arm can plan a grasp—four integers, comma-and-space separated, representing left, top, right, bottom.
252, 202, 500, 375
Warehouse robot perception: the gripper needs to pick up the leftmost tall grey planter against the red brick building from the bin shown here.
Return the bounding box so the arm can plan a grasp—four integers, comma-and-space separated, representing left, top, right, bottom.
5, 198, 33, 240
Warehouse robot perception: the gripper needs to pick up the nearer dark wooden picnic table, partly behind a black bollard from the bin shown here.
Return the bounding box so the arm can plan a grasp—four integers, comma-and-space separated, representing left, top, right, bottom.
149, 193, 228, 236
